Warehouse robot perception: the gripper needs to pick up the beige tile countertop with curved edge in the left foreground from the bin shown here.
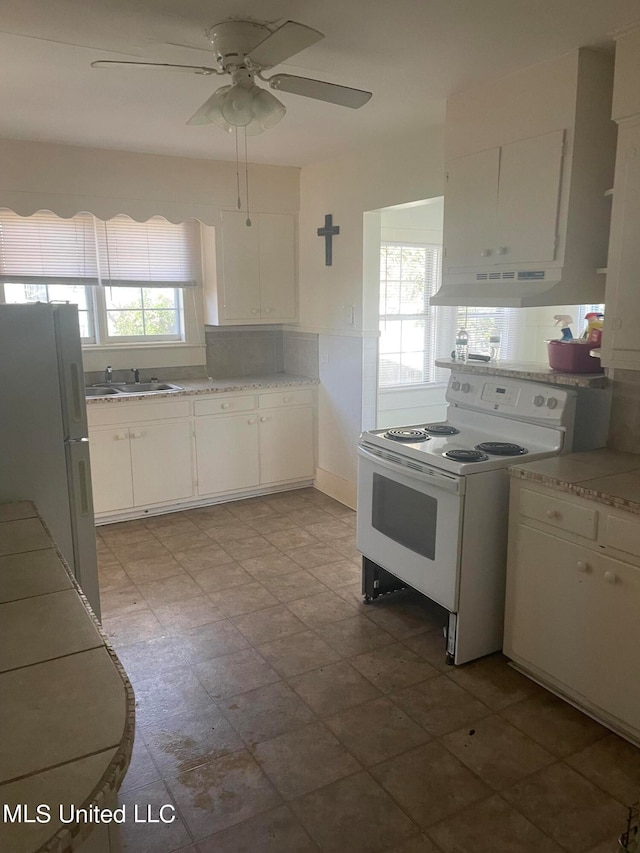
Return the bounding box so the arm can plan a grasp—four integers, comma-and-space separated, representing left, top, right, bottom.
0, 501, 134, 853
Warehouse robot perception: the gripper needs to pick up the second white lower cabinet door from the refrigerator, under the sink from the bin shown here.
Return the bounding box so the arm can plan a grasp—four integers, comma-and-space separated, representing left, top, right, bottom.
129, 421, 193, 506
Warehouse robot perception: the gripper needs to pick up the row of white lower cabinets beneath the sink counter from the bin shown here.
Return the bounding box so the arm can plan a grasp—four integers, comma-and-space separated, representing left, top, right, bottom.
88, 388, 315, 521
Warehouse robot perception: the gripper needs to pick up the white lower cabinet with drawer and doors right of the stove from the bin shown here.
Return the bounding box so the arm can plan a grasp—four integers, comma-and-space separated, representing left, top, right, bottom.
504, 481, 640, 741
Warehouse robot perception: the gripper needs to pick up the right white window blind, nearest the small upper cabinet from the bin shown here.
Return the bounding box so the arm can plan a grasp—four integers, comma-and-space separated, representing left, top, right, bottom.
96, 215, 197, 288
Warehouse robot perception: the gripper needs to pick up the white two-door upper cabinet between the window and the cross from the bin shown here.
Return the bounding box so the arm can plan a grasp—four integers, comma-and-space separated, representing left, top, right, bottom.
202, 210, 297, 325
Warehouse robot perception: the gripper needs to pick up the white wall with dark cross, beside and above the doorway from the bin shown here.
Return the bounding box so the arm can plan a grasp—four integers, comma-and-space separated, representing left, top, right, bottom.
300, 128, 444, 505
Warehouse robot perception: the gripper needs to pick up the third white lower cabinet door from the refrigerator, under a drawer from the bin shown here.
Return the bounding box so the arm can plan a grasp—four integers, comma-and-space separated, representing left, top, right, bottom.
196, 413, 259, 495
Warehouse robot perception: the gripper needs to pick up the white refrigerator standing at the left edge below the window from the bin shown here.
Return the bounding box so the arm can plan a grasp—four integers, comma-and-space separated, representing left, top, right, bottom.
0, 303, 100, 618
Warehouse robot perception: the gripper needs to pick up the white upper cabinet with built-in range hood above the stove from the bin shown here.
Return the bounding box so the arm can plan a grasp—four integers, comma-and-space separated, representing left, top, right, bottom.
432, 49, 615, 307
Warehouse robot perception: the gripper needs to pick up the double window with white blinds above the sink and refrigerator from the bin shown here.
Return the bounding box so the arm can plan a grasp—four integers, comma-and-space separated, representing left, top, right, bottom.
0, 209, 199, 343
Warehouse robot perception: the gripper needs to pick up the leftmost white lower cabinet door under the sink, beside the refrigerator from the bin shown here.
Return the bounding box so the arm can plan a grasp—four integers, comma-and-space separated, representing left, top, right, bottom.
89, 426, 133, 513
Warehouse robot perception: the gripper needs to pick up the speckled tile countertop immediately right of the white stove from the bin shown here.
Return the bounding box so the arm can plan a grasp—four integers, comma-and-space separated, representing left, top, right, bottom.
509, 448, 640, 514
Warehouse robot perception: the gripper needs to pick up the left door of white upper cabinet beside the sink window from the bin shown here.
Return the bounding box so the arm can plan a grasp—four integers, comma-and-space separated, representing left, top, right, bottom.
222, 210, 260, 320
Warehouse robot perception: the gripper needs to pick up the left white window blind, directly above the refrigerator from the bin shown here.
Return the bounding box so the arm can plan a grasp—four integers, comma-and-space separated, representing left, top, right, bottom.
0, 209, 100, 285
